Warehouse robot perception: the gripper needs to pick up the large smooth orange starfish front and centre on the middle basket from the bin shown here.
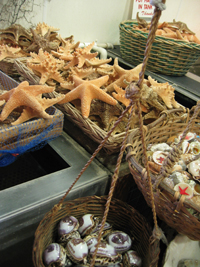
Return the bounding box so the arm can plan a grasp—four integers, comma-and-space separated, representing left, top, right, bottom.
59, 75, 117, 118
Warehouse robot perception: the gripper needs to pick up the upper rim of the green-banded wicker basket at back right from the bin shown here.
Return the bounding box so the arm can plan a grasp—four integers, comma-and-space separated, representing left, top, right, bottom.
119, 20, 200, 52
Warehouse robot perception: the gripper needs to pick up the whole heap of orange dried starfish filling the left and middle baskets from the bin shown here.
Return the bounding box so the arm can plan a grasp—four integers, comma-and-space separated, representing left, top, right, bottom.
0, 23, 179, 133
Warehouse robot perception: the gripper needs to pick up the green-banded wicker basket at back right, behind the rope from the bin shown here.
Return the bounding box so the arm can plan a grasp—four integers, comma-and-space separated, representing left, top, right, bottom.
119, 20, 200, 76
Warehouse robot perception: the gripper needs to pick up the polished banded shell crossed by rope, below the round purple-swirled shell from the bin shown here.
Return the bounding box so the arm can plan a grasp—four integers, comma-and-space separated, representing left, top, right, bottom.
89, 242, 122, 266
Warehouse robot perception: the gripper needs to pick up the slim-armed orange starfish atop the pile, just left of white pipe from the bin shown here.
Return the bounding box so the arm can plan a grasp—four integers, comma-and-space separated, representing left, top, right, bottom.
64, 42, 98, 69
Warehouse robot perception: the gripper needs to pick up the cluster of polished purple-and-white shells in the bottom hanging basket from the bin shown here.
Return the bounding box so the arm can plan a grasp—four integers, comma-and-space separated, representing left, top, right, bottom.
43, 214, 142, 267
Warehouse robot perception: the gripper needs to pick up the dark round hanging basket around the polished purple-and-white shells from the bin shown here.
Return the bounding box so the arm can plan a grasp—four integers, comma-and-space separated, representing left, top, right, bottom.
33, 196, 160, 267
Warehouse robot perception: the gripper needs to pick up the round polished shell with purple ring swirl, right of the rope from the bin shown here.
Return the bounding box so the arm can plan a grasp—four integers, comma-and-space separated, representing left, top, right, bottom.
107, 231, 132, 253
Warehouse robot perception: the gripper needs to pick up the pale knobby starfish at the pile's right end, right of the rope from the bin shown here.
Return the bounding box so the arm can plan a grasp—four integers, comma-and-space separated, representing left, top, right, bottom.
148, 76, 180, 109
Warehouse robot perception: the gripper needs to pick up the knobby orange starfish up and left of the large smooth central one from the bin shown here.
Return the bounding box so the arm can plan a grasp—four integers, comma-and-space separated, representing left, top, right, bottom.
27, 49, 65, 84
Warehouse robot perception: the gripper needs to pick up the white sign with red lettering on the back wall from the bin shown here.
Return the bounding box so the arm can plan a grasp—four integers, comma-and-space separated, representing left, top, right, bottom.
132, 0, 154, 19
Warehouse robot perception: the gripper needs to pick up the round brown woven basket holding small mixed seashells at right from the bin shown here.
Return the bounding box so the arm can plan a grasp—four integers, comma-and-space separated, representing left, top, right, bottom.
127, 110, 200, 240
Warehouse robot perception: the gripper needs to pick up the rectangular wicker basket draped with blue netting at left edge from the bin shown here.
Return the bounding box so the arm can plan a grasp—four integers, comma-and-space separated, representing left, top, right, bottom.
0, 72, 64, 166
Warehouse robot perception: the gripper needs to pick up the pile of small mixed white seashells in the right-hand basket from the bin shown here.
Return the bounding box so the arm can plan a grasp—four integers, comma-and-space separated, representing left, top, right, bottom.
147, 132, 200, 216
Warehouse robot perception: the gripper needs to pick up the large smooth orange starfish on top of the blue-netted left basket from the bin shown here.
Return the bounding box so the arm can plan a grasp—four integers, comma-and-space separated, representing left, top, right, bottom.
0, 81, 60, 121
